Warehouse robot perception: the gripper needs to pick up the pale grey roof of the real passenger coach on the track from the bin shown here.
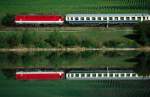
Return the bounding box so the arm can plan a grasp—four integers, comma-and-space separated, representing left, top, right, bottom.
66, 13, 150, 17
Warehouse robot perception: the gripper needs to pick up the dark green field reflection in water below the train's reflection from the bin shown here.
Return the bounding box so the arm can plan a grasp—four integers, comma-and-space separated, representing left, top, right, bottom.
0, 73, 150, 97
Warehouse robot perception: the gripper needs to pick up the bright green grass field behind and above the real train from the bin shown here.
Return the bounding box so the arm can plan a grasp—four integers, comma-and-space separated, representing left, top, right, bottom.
0, 0, 150, 21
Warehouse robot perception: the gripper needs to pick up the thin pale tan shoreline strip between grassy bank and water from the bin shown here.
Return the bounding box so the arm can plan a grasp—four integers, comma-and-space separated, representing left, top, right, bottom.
0, 47, 150, 52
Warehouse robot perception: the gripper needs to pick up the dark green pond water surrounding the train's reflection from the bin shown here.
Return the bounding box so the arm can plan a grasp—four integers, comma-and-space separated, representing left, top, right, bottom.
0, 51, 150, 97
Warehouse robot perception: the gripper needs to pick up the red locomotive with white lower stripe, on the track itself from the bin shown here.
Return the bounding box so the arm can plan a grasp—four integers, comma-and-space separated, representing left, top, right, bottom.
15, 15, 64, 24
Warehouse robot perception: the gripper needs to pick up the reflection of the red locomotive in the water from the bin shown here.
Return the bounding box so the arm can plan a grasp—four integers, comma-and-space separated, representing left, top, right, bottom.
16, 68, 64, 80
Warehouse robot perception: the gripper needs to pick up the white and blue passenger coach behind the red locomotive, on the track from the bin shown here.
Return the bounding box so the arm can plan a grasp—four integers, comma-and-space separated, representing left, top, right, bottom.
65, 14, 150, 24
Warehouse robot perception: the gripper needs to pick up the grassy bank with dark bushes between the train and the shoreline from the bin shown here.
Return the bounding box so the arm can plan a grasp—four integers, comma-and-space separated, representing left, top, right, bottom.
0, 27, 137, 48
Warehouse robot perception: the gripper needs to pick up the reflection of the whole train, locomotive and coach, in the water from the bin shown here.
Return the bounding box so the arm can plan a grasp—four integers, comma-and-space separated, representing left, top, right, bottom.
16, 68, 150, 80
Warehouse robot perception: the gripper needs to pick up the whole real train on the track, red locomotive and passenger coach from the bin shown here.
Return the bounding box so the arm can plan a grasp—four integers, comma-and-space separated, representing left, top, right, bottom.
15, 13, 150, 25
